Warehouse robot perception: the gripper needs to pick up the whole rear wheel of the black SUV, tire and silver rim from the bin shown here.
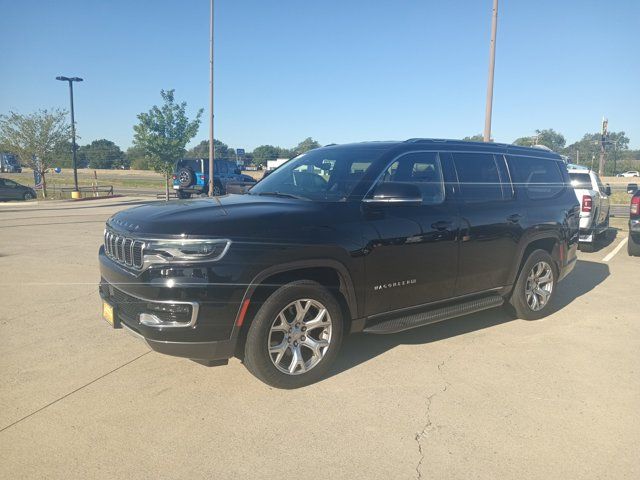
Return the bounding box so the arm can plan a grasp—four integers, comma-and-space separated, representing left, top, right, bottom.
509, 250, 557, 320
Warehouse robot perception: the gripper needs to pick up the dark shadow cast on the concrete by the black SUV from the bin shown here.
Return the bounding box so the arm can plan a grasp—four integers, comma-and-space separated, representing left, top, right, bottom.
329, 260, 609, 376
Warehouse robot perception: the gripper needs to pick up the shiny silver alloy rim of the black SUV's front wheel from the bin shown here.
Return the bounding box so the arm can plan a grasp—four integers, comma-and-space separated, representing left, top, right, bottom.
268, 298, 333, 375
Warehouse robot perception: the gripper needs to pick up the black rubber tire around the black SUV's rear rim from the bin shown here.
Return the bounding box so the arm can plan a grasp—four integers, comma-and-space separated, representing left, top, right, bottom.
509, 250, 558, 320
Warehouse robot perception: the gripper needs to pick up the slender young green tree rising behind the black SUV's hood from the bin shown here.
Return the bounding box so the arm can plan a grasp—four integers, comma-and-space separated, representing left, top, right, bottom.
133, 90, 203, 200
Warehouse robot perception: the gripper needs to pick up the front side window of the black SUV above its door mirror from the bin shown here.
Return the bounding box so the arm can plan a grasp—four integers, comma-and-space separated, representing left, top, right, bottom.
379, 152, 444, 205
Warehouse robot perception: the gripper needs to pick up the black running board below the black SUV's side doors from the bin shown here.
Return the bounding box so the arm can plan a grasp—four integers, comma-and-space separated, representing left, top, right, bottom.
364, 295, 504, 335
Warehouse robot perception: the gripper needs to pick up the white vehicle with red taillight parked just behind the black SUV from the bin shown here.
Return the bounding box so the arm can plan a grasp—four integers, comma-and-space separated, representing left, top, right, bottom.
569, 167, 611, 250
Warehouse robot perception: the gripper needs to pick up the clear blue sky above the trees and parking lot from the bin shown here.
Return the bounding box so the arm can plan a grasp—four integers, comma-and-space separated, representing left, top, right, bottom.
0, 0, 640, 149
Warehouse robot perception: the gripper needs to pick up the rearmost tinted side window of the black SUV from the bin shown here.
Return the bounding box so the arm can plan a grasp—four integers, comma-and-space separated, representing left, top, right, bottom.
509, 157, 565, 200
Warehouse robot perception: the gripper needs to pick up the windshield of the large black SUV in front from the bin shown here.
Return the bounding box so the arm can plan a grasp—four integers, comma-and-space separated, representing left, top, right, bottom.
249, 147, 386, 202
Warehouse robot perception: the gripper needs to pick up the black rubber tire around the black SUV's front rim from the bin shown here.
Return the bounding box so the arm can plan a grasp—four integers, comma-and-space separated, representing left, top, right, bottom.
244, 280, 344, 389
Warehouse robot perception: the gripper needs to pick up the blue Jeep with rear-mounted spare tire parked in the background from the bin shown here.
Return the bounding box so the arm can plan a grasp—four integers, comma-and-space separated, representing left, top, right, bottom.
173, 158, 256, 199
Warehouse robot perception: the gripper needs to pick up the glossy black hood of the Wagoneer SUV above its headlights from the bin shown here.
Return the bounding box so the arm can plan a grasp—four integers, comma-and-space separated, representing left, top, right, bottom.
107, 195, 330, 238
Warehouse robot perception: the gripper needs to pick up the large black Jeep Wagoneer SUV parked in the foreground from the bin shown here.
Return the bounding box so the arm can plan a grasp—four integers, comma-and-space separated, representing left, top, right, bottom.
99, 139, 580, 388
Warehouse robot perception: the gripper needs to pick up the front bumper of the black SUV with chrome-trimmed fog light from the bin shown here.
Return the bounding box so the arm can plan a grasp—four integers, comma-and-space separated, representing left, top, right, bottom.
99, 247, 246, 360
